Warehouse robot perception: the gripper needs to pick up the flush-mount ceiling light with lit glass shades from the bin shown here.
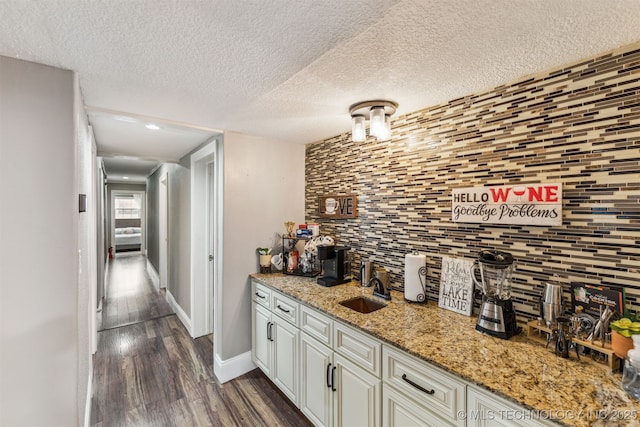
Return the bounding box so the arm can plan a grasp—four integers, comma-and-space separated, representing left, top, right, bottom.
349, 100, 398, 142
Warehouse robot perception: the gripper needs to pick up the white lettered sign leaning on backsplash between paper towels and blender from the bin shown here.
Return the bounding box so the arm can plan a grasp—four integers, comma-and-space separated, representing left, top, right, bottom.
438, 256, 473, 316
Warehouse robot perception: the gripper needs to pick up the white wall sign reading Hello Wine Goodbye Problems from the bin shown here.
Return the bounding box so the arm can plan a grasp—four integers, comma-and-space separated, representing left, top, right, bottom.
451, 183, 562, 226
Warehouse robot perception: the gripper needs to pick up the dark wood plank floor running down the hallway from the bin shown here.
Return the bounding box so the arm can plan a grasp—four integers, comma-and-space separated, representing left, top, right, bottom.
91, 256, 310, 426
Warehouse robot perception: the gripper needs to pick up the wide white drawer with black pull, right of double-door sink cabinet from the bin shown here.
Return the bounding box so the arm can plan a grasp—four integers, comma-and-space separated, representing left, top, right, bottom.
382, 345, 466, 426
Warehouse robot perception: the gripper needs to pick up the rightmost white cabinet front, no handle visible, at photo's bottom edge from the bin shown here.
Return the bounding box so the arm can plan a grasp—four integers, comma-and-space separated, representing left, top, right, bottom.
466, 386, 556, 427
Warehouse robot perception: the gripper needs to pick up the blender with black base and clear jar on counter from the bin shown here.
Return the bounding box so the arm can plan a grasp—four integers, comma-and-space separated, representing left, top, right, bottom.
471, 250, 522, 339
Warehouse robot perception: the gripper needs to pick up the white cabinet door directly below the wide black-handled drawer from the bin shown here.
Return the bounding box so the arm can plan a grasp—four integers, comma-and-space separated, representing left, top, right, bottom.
382, 384, 455, 427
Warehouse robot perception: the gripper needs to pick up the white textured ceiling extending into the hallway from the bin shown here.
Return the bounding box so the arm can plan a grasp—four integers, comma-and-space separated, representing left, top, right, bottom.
0, 0, 640, 171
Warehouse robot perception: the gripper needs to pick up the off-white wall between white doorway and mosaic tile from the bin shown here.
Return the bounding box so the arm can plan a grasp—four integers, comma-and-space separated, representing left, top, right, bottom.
214, 132, 305, 368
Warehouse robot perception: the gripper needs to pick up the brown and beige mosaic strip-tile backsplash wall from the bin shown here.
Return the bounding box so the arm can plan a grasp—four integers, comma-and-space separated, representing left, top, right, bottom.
306, 45, 640, 321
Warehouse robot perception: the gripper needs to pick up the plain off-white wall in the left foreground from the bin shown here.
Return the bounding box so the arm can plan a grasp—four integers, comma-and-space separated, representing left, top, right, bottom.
0, 57, 80, 426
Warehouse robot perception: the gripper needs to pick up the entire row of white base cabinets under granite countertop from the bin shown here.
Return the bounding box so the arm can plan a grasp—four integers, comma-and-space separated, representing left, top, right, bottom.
252, 282, 555, 427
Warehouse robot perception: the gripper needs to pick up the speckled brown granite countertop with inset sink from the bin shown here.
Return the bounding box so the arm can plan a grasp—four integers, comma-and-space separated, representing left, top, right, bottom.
251, 274, 640, 426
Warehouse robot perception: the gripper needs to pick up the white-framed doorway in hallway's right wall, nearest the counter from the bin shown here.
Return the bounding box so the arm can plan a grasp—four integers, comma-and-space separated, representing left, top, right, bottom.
190, 138, 220, 338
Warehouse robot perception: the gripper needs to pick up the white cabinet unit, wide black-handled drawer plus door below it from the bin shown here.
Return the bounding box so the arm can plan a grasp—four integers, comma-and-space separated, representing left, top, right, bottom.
382, 345, 466, 427
